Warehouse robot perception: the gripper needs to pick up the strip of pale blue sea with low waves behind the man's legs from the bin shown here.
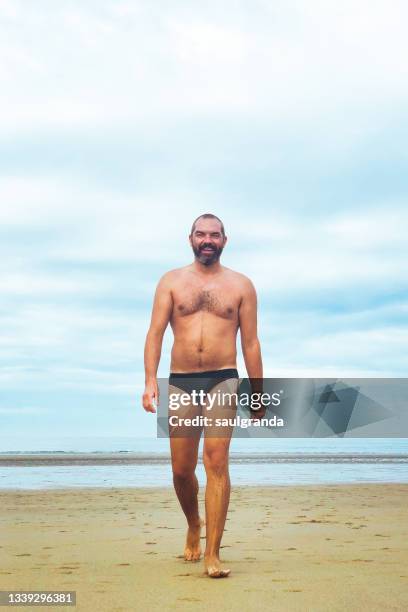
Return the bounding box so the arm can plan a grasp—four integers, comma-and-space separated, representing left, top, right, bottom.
0, 437, 408, 490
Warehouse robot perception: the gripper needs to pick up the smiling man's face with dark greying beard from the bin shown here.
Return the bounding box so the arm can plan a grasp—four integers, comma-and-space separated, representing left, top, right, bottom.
190, 219, 227, 266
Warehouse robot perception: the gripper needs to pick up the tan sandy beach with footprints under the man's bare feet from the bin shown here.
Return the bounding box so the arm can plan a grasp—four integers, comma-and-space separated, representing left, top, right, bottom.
0, 484, 408, 612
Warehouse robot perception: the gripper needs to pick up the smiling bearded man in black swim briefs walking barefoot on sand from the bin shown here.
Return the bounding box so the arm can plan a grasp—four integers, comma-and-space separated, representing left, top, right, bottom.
143, 214, 263, 578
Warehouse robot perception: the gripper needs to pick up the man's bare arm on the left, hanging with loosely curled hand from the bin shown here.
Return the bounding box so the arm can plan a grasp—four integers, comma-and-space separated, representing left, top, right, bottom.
143, 273, 173, 412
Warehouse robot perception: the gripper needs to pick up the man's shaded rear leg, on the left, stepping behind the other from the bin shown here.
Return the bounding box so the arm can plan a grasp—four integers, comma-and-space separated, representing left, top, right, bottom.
170, 388, 204, 561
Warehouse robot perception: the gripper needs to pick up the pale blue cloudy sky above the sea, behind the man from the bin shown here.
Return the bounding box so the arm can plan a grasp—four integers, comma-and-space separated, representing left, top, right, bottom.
0, 0, 408, 439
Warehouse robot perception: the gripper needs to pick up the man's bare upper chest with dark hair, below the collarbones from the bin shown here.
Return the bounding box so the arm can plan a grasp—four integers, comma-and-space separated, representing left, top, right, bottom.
173, 288, 239, 320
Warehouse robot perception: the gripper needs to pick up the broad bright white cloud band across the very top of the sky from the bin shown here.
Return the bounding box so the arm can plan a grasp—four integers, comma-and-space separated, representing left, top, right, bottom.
0, 0, 408, 137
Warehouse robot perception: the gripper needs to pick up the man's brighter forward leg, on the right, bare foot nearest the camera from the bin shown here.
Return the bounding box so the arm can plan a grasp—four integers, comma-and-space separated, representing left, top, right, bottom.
203, 379, 238, 578
